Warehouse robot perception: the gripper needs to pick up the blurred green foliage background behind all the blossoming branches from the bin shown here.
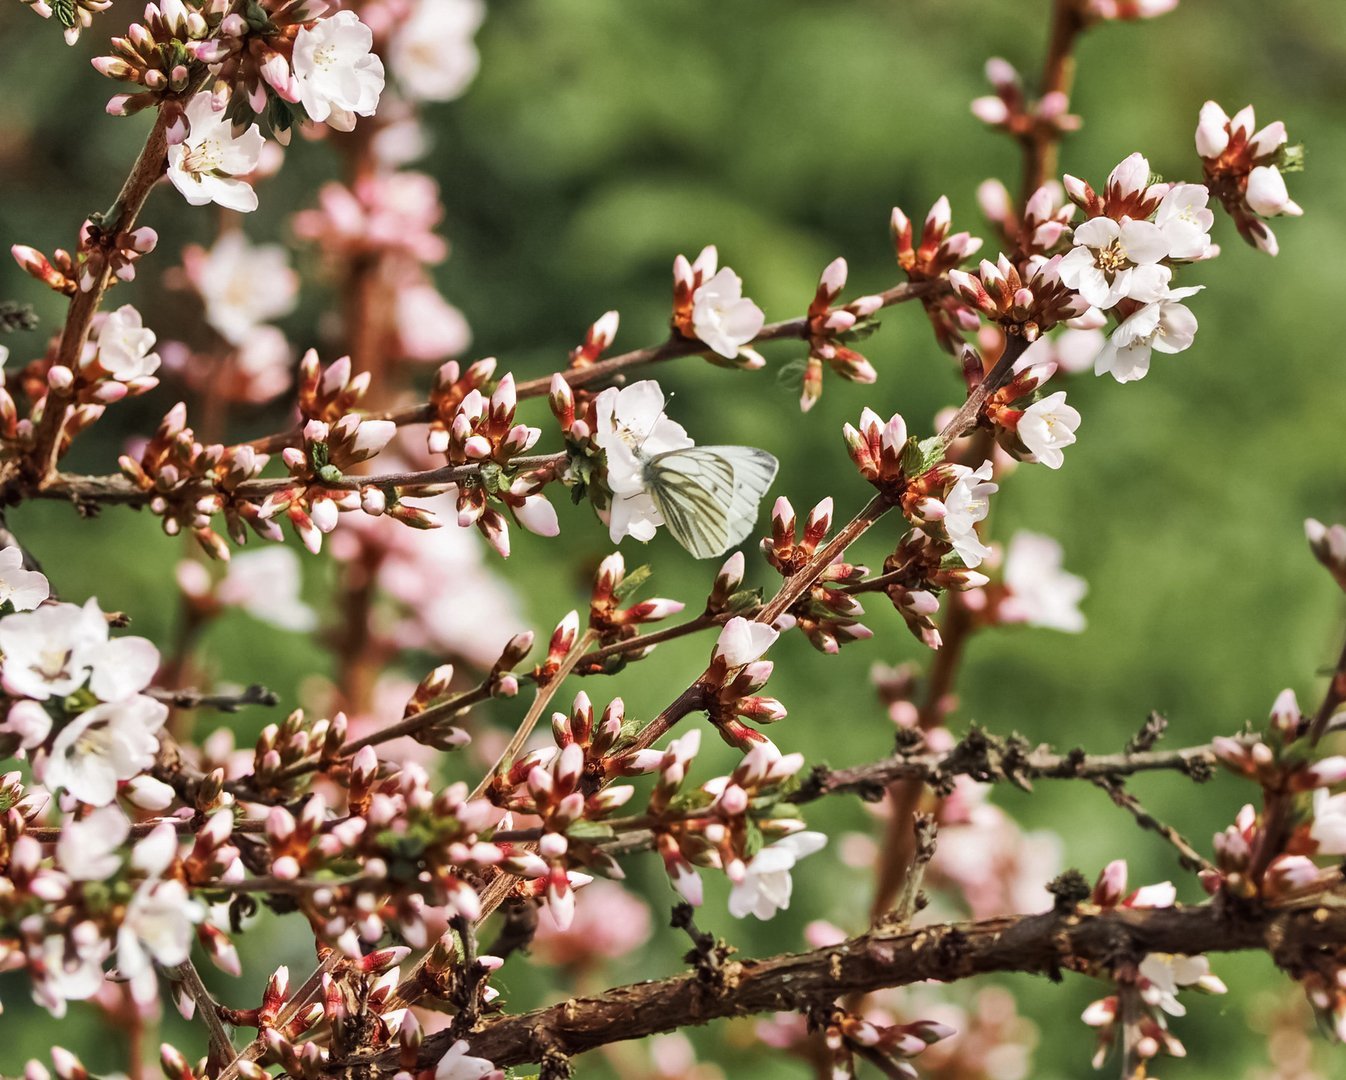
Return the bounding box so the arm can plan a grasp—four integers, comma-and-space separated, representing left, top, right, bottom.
0, 0, 1346, 1080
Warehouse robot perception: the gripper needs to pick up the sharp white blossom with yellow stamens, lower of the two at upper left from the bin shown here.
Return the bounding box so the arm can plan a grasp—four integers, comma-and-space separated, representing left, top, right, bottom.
168, 92, 264, 213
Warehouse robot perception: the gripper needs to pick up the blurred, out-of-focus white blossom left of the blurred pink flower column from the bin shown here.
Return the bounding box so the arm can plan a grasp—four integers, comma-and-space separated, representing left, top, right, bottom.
183, 229, 299, 345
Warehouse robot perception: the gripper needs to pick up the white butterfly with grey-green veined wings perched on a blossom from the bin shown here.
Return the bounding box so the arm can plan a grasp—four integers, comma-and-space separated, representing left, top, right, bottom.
637, 446, 779, 559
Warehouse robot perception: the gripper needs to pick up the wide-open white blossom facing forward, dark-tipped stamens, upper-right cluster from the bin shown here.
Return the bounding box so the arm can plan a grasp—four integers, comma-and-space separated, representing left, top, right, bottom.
1059, 217, 1172, 311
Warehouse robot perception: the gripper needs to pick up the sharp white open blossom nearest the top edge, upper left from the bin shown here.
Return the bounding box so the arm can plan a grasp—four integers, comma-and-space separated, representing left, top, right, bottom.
293, 11, 384, 131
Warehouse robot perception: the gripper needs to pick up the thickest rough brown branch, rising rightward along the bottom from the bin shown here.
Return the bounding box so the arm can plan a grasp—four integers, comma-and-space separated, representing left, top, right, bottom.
355, 904, 1346, 1076
